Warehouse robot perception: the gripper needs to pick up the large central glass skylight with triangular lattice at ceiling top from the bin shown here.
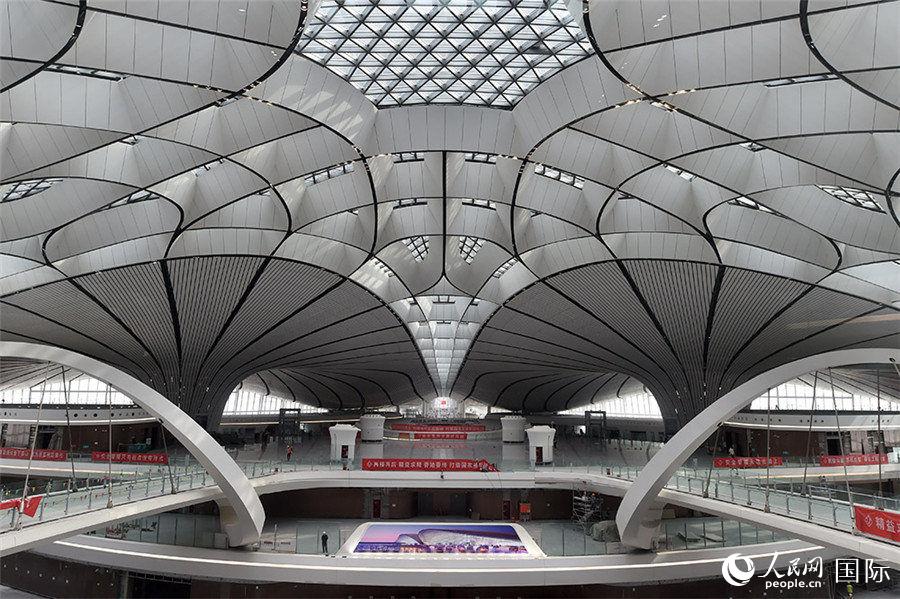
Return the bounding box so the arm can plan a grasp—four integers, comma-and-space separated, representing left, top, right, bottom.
297, 0, 592, 107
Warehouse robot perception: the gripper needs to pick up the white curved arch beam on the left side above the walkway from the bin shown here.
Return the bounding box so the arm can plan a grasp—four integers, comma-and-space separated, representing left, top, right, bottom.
0, 341, 266, 546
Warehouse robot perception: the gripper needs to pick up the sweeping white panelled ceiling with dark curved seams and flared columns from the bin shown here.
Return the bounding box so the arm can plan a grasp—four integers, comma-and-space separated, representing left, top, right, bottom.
0, 0, 900, 428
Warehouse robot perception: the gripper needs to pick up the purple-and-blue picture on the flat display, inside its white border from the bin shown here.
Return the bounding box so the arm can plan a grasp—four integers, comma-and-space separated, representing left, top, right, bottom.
352, 522, 533, 556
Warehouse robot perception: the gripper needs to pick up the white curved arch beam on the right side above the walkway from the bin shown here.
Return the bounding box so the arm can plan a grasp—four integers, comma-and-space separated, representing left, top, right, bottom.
616, 348, 900, 549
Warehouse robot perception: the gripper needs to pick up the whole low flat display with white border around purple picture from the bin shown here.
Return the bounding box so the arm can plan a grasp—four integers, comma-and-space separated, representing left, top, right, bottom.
338, 522, 544, 558
